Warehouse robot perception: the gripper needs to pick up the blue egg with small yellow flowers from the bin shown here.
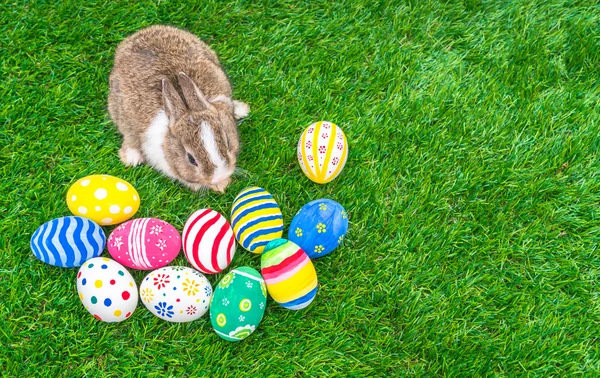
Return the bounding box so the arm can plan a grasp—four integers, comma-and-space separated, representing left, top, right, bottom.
288, 198, 348, 259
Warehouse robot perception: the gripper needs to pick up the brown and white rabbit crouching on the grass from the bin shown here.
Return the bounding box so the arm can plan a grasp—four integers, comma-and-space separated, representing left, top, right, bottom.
108, 25, 250, 192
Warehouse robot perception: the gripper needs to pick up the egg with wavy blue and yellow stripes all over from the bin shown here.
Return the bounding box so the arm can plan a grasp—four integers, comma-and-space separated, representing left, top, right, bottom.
231, 186, 283, 253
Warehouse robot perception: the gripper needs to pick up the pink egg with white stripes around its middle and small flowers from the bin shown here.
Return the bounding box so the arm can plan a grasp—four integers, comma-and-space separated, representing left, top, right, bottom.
107, 218, 181, 270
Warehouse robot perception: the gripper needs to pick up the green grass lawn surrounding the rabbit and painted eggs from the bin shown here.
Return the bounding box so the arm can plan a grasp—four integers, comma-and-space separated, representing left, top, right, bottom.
0, 0, 600, 377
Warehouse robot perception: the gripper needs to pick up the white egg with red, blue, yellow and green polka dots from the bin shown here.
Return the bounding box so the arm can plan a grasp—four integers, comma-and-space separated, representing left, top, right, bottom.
77, 257, 138, 323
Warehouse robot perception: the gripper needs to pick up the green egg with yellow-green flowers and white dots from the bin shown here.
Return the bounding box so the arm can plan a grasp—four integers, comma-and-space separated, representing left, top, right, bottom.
210, 266, 267, 341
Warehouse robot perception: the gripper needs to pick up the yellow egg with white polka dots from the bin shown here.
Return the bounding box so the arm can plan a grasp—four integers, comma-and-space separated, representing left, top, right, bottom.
67, 175, 140, 226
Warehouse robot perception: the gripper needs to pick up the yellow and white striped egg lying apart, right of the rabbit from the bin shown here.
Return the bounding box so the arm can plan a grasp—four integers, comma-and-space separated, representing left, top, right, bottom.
298, 121, 348, 184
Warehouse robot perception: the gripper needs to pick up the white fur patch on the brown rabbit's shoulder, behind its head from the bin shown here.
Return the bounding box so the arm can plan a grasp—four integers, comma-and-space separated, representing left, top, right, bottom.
142, 109, 176, 178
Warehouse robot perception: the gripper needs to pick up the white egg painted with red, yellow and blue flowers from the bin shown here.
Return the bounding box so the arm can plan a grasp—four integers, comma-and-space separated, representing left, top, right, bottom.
140, 266, 212, 323
